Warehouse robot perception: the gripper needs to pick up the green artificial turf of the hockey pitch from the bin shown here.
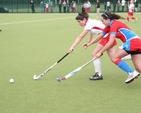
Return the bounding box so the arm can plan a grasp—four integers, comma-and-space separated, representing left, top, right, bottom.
0, 13, 141, 113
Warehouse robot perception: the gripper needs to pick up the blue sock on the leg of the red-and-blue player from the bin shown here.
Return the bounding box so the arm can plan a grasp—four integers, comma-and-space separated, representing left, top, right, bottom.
118, 60, 134, 73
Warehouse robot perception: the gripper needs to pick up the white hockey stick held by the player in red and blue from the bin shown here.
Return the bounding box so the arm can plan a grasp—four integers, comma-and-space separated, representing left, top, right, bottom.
56, 58, 96, 82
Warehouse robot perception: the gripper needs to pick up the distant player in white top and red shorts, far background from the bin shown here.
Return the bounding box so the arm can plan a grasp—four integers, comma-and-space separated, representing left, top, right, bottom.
126, 0, 137, 22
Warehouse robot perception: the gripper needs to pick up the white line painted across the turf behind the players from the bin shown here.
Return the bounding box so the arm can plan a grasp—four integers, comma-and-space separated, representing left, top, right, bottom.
0, 17, 74, 25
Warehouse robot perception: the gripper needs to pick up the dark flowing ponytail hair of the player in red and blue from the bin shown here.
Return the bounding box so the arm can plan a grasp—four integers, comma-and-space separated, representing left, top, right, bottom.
101, 11, 125, 20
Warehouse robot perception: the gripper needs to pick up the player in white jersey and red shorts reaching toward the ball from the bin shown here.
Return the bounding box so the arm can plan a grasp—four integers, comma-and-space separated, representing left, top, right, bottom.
68, 8, 116, 80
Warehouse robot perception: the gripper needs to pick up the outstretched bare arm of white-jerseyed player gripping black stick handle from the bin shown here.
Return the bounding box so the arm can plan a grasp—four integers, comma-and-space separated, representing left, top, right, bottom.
68, 30, 89, 53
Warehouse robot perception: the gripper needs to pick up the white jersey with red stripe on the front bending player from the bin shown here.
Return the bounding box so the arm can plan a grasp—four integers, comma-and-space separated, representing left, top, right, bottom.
84, 18, 105, 34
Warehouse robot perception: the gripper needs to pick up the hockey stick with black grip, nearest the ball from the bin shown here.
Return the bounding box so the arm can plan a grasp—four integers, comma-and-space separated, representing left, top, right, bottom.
33, 53, 69, 80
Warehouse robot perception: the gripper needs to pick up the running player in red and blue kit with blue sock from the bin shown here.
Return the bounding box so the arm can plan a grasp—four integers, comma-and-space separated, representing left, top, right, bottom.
87, 12, 141, 83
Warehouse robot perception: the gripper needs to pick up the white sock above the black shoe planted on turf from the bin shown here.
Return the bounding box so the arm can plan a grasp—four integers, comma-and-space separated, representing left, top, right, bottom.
93, 58, 102, 76
